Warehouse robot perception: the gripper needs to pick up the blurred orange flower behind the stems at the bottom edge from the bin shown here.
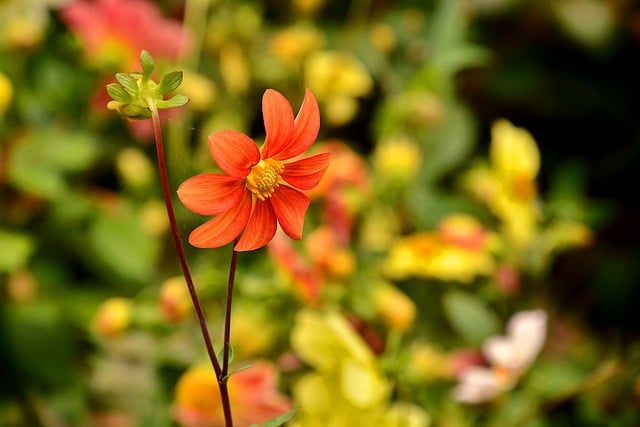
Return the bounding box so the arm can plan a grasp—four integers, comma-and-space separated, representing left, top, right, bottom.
173, 361, 292, 427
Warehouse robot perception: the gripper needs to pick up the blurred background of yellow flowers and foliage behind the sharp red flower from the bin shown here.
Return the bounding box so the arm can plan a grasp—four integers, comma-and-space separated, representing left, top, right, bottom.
0, 0, 640, 427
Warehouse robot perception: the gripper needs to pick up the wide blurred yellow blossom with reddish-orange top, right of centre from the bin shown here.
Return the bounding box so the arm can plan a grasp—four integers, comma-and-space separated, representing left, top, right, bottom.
384, 214, 498, 283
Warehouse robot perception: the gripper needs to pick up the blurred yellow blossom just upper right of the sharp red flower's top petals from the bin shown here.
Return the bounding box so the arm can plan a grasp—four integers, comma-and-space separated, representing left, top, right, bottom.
305, 51, 373, 125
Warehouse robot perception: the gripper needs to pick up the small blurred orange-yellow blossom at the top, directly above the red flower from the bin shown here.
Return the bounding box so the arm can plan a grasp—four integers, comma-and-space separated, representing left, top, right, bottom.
271, 23, 324, 64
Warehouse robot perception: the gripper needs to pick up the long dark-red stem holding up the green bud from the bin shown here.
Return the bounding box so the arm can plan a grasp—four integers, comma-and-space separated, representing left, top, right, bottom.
147, 99, 225, 382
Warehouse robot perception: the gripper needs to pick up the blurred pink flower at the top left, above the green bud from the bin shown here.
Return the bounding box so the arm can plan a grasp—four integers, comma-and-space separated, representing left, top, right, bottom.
60, 0, 191, 70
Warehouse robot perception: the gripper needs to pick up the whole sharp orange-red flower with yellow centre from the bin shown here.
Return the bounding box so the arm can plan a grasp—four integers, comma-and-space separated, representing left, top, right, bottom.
178, 89, 331, 251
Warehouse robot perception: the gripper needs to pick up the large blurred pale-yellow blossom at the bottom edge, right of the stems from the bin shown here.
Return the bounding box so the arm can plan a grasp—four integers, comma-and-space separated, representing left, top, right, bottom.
291, 309, 429, 427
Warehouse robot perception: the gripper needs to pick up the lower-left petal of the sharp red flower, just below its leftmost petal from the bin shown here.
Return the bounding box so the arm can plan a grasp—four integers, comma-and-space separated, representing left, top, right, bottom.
189, 191, 251, 248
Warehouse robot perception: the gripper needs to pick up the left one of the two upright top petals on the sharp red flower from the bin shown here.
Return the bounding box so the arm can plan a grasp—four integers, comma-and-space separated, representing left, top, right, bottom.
262, 89, 293, 159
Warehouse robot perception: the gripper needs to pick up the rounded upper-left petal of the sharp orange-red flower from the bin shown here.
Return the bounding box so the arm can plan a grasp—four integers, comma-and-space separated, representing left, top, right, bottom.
209, 130, 260, 178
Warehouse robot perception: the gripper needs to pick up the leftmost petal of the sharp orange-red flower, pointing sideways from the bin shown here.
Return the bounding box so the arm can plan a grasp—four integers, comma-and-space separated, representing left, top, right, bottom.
178, 173, 244, 215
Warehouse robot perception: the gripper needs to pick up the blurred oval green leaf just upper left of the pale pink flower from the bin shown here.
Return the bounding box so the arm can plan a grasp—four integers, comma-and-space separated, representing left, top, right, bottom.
443, 291, 501, 346
